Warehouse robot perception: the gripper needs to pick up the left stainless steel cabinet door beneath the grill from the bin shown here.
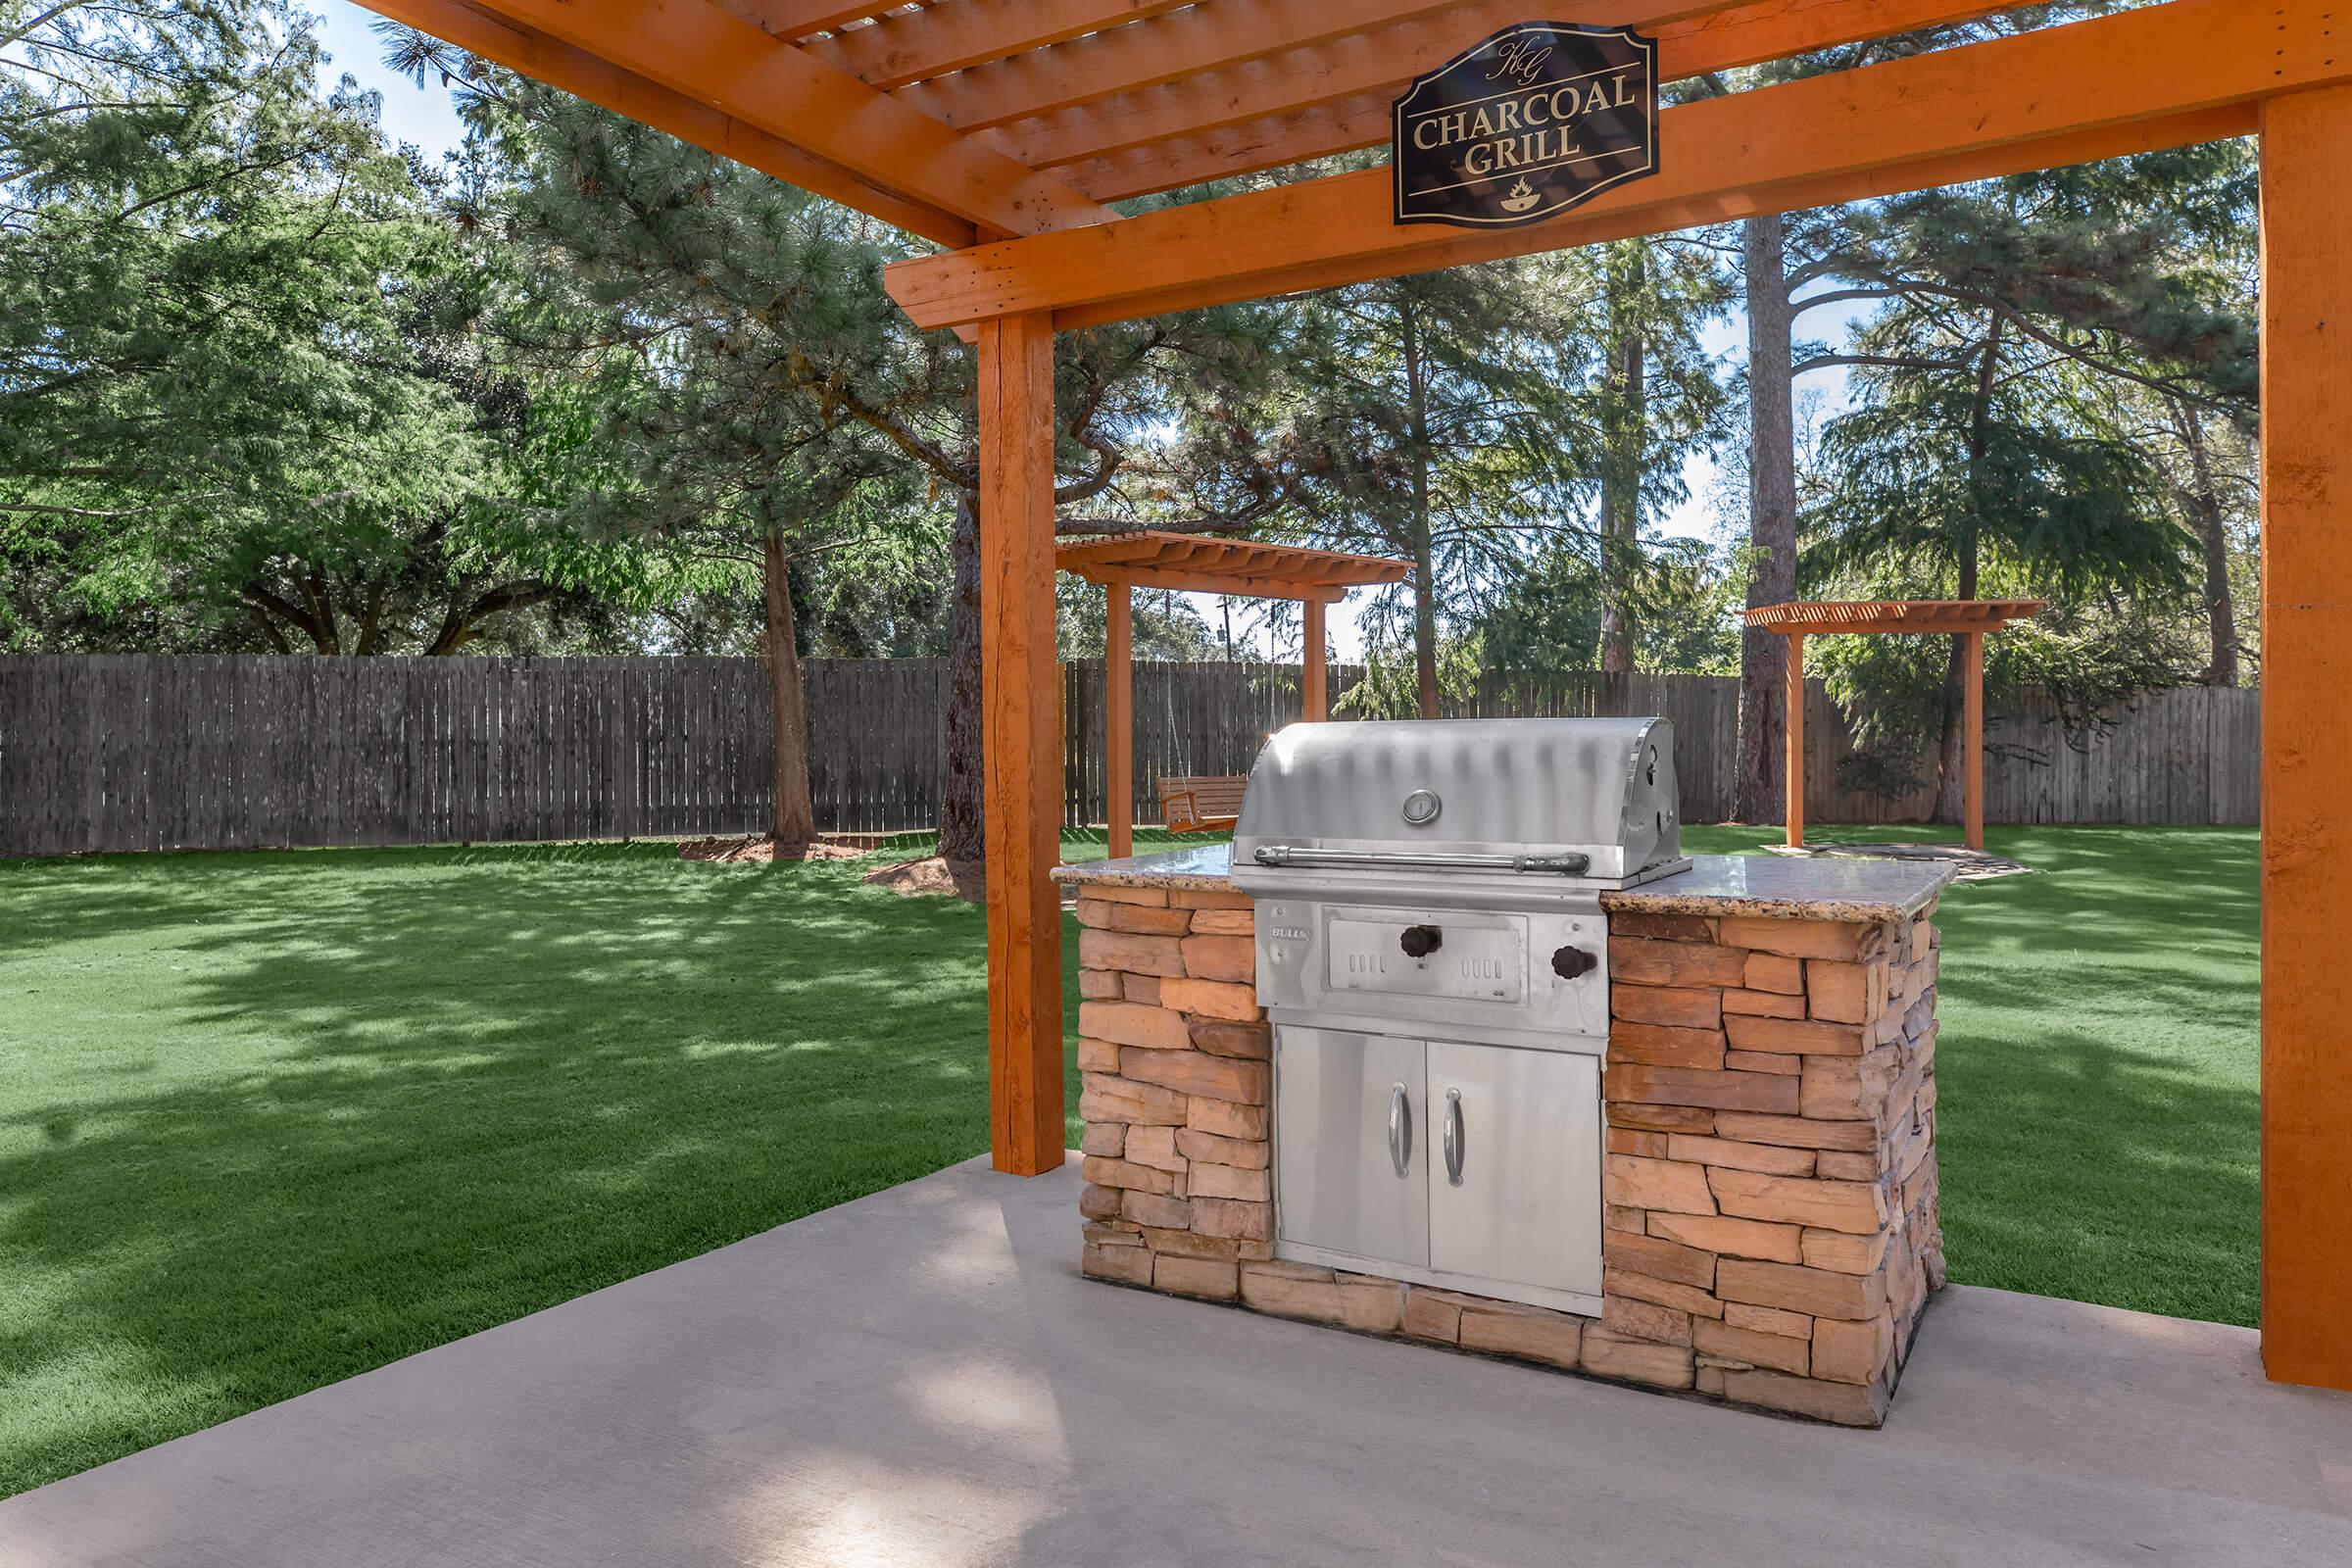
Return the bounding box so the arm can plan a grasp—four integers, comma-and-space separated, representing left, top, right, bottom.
1275, 1025, 1433, 1267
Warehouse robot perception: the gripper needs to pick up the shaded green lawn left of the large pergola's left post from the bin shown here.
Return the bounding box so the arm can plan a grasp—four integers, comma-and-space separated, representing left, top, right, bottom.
0, 847, 1075, 1493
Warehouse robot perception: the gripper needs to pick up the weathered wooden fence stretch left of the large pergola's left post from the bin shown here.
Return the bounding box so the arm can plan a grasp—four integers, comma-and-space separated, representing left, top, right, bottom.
0, 656, 948, 856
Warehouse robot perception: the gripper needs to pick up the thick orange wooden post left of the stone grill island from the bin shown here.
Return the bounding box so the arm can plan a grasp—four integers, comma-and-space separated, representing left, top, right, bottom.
978, 315, 1065, 1175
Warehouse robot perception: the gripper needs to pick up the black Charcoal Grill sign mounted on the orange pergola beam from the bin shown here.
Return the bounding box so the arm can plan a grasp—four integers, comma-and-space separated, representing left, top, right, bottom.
1393, 22, 1658, 228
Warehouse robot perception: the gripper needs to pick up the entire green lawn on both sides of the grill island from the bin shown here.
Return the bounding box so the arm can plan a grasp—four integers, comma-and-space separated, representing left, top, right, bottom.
0, 830, 2256, 1495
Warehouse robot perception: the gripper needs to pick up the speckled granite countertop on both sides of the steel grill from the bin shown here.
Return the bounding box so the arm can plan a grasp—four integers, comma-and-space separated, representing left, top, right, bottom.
1054, 844, 1952, 921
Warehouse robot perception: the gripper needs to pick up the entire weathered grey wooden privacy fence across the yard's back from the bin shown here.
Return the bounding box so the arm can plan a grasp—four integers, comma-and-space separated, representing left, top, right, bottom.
0, 656, 2260, 856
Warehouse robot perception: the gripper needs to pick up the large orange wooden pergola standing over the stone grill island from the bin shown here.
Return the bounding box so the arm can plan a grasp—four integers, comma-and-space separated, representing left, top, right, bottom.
367, 0, 2352, 1387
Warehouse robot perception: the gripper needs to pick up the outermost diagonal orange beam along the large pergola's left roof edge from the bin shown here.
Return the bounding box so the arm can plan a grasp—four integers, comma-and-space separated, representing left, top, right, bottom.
360, 0, 976, 247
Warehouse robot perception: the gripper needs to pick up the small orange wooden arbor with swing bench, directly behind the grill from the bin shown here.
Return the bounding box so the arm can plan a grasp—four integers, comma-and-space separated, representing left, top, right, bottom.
1054, 529, 1413, 858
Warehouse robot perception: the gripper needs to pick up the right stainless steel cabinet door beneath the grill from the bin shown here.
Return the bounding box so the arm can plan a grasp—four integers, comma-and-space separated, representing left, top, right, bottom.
1430, 1042, 1601, 1296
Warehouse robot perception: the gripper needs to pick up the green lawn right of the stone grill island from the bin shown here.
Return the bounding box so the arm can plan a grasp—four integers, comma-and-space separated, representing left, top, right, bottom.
1684, 827, 2260, 1326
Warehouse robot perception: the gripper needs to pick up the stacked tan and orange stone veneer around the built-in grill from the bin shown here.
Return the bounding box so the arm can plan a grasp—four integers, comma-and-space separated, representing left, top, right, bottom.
1077, 884, 1942, 1425
